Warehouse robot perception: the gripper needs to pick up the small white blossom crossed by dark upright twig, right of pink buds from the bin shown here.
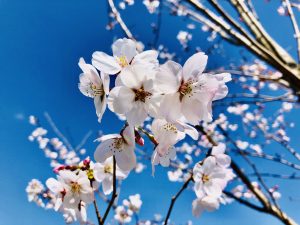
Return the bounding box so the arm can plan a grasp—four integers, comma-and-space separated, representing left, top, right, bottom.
93, 157, 128, 195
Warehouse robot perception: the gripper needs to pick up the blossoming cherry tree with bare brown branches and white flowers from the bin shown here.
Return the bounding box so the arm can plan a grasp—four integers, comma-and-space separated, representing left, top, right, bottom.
26, 0, 300, 225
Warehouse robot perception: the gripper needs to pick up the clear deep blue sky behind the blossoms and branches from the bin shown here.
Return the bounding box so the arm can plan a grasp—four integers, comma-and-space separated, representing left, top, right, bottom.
0, 0, 300, 225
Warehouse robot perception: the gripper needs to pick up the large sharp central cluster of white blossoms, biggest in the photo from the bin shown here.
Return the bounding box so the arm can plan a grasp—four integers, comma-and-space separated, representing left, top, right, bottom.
79, 38, 231, 171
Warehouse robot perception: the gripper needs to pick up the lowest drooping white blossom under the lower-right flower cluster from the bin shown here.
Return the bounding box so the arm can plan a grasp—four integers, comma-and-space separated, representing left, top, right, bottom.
192, 196, 220, 217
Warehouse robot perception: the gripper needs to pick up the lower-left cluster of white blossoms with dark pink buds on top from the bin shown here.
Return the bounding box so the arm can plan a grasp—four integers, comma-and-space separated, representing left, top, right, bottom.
26, 157, 129, 223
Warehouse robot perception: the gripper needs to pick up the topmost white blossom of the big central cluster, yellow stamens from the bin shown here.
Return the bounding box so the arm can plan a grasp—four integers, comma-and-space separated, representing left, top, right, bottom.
92, 38, 158, 74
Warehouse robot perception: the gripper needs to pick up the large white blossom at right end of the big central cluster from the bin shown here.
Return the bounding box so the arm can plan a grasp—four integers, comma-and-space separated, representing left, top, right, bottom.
156, 52, 231, 125
